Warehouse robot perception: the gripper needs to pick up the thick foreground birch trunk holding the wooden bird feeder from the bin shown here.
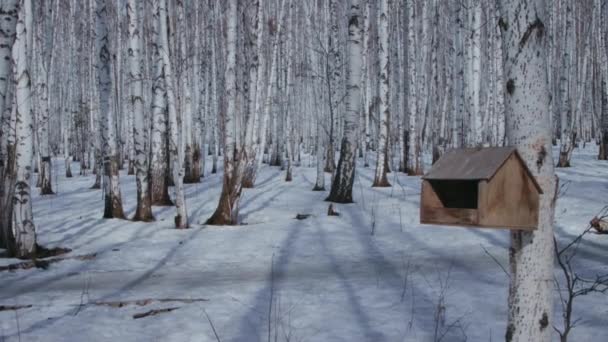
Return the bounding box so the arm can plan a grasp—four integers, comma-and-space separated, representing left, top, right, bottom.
499, 0, 556, 342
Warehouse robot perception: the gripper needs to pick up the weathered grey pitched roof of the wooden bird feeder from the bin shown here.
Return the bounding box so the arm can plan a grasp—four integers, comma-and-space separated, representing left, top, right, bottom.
423, 147, 542, 193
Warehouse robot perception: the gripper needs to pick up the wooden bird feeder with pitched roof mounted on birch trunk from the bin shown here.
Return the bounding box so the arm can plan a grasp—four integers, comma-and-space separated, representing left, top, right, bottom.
420, 147, 542, 230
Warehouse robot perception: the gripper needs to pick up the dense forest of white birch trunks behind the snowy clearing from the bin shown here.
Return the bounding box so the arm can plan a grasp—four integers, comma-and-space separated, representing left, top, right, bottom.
0, 0, 608, 341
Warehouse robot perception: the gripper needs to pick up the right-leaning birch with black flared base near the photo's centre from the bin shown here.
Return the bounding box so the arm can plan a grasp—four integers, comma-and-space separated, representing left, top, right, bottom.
327, 0, 360, 203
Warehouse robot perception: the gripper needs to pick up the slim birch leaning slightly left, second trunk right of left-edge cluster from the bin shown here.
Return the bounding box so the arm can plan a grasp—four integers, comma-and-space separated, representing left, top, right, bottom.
95, 0, 125, 218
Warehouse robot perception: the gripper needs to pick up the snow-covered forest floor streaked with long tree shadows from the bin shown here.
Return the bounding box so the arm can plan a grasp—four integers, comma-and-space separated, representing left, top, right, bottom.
0, 146, 608, 341
